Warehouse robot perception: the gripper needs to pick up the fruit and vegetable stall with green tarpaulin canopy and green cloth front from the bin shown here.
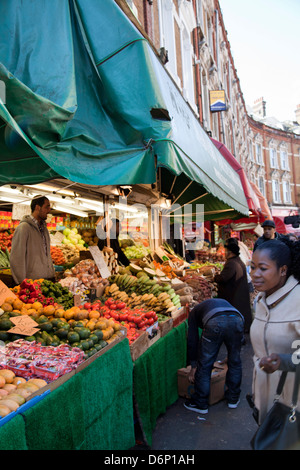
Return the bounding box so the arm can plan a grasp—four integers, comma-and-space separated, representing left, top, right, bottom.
0, 0, 254, 449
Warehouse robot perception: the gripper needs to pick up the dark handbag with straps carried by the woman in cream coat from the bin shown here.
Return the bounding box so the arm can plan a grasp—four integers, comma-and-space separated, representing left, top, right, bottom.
251, 366, 300, 450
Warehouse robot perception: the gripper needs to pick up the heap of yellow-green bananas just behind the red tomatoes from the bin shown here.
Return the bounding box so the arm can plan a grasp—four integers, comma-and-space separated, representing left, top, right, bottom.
104, 273, 181, 313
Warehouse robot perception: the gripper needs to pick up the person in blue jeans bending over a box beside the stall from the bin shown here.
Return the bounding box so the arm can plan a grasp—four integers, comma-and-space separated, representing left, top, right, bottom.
184, 298, 244, 414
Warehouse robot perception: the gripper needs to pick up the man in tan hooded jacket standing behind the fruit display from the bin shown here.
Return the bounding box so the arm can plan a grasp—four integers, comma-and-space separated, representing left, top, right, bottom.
10, 196, 55, 284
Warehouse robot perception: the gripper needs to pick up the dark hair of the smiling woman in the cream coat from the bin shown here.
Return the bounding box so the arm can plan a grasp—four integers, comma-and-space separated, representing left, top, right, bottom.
255, 237, 300, 281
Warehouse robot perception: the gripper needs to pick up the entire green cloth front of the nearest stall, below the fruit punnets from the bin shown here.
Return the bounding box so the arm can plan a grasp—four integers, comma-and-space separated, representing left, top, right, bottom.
0, 338, 135, 450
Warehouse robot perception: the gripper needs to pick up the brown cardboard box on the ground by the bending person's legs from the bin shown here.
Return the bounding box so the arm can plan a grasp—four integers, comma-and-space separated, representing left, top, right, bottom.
177, 362, 227, 405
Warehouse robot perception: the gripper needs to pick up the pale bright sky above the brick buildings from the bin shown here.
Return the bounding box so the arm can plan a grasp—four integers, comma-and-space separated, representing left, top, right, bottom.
219, 0, 300, 121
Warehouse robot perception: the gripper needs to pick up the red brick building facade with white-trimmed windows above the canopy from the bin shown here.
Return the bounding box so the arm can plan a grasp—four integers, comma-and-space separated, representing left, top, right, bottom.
115, 0, 300, 220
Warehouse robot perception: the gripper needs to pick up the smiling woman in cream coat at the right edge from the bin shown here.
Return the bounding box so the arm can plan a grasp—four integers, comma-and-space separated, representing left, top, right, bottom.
250, 239, 300, 424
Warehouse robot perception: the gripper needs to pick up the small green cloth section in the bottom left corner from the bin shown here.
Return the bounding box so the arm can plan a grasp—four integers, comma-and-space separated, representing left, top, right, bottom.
0, 414, 27, 450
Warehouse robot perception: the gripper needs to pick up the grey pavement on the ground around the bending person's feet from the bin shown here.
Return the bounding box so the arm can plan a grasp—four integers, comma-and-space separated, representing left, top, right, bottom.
136, 335, 257, 451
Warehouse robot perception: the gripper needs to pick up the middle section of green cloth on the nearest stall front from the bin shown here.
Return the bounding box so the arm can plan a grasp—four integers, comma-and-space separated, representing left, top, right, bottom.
23, 374, 84, 450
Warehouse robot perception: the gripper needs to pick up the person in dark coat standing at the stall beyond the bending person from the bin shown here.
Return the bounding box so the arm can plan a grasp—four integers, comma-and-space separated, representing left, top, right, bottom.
214, 238, 252, 333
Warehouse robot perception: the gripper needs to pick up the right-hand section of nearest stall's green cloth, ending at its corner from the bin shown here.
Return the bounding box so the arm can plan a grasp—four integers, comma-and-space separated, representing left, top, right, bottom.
80, 338, 135, 450
